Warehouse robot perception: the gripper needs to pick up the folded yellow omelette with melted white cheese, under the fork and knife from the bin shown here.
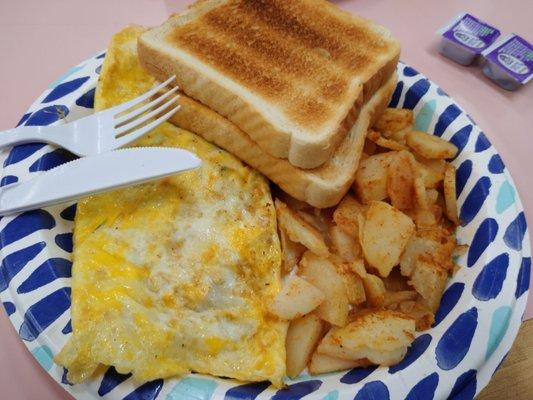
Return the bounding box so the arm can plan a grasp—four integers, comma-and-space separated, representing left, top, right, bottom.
56, 26, 287, 386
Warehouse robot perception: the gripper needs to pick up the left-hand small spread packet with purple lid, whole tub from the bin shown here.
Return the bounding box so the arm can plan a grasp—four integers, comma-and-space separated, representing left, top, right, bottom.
437, 12, 500, 65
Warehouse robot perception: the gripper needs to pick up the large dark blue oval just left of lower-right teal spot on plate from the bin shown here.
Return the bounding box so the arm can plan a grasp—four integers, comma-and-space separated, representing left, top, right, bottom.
435, 307, 478, 371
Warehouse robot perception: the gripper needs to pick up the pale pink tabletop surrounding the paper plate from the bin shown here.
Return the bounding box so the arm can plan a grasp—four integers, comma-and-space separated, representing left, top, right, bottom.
0, 0, 533, 400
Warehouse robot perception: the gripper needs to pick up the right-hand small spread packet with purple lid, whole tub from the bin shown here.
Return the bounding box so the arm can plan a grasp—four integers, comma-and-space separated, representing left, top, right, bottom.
482, 34, 533, 90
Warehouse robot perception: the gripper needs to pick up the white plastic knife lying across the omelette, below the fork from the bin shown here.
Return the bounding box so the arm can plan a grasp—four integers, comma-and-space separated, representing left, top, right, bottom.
0, 147, 202, 215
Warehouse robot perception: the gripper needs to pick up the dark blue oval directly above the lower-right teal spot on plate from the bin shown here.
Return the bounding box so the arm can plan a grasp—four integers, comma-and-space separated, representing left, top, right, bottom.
472, 253, 509, 301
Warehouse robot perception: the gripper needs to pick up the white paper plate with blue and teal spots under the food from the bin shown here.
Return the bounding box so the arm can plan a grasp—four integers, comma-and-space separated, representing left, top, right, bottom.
0, 53, 531, 400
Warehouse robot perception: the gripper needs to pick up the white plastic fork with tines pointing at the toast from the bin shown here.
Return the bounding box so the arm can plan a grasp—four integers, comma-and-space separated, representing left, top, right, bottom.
0, 76, 180, 157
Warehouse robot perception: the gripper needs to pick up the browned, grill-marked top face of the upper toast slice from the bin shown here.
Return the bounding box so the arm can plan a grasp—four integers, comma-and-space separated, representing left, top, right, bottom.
168, 0, 394, 131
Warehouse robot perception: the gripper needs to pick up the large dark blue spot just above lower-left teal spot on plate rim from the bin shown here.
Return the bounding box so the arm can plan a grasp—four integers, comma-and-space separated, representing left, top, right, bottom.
19, 287, 70, 341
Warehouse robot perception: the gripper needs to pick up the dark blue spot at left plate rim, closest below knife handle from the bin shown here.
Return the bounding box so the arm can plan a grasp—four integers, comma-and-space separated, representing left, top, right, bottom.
0, 210, 56, 247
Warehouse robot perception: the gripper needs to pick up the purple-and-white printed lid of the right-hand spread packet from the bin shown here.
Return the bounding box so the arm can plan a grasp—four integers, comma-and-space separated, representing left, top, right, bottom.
483, 35, 533, 83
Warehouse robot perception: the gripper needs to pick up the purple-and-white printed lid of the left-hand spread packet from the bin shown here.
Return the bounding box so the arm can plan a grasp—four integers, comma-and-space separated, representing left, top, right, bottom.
442, 13, 500, 54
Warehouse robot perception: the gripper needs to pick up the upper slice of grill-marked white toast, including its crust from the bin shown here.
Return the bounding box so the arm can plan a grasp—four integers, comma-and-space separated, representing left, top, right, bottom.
138, 0, 400, 168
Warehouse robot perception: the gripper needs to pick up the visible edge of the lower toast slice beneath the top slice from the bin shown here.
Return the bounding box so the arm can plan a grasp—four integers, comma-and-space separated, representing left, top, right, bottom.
170, 74, 397, 208
